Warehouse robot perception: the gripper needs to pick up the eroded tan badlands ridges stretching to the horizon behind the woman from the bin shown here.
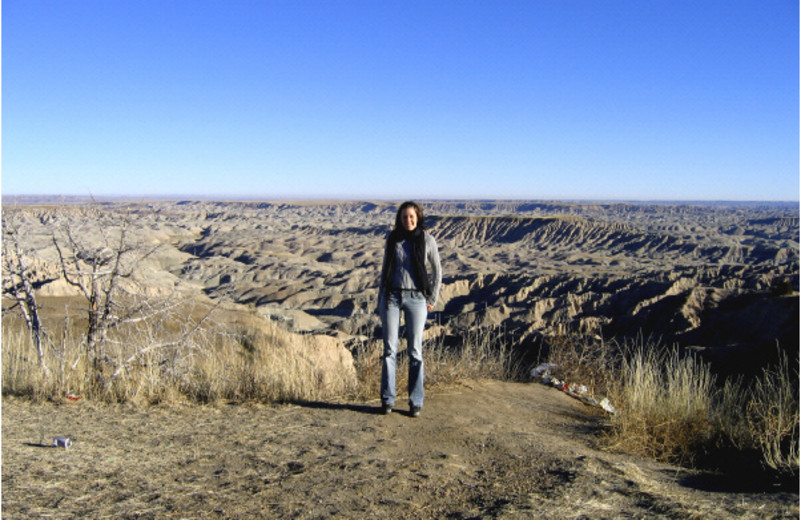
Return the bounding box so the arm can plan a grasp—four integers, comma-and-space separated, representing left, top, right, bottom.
3, 201, 800, 374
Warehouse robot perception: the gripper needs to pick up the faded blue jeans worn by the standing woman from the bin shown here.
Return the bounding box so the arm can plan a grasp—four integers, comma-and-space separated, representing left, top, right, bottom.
381, 291, 428, 408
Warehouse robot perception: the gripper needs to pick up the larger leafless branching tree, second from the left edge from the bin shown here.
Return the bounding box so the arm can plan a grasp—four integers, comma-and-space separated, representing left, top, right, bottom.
52, 206, 216, 388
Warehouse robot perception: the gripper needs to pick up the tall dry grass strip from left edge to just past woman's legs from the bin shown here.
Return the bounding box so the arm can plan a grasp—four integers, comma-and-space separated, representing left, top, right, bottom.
2, 302, 520, 405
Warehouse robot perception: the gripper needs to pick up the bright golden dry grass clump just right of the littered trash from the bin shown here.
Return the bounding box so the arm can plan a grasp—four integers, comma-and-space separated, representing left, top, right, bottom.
548, 336, 715, 463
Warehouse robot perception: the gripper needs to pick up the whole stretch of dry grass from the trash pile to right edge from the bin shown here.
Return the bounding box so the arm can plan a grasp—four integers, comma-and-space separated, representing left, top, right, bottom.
549, 338, 800, 476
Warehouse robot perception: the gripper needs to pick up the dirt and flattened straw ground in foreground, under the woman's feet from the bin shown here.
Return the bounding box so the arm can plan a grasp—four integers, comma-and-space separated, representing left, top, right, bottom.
2, 382, 798, 519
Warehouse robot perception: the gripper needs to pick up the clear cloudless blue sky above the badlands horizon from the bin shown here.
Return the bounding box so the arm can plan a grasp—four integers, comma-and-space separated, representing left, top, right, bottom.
2, 0, 800, 201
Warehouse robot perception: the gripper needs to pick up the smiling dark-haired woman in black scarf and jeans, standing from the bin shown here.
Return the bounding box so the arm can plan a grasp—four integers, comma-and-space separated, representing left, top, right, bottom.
378, 202, 442, 417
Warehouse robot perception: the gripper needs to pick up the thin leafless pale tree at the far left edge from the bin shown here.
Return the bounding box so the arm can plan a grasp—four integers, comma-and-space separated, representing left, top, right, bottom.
2, 217, 50, 377
